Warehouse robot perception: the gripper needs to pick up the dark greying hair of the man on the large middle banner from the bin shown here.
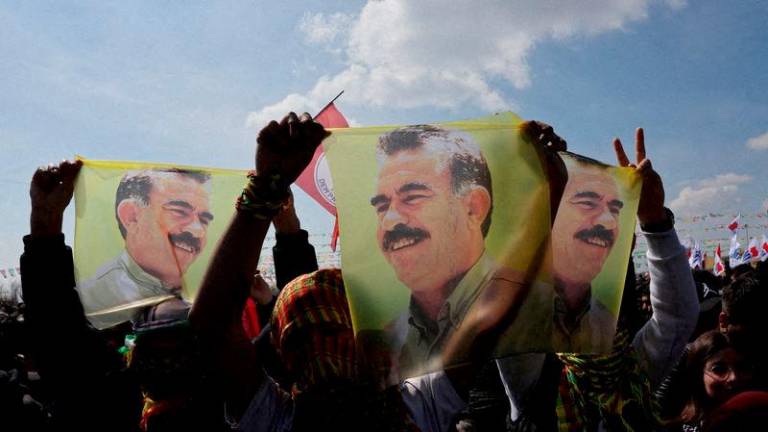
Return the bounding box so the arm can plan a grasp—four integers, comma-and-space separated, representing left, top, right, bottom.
376, 125, 493, 237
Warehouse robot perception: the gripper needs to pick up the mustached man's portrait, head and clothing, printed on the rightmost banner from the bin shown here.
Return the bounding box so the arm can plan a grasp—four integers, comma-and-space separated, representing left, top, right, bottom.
552, 154, 624, 352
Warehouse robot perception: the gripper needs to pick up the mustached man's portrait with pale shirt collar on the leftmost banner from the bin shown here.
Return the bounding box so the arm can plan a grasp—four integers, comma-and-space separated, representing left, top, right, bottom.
78, 169, 213, 328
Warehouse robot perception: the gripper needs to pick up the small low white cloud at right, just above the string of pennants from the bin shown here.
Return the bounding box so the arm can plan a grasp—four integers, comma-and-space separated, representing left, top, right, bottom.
669, 173, 752, 215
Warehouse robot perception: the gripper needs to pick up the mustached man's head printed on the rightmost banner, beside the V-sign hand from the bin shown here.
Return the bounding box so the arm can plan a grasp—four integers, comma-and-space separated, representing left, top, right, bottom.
552, 154, 624, 285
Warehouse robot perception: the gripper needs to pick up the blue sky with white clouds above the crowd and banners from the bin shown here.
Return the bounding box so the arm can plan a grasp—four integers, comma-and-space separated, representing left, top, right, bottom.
0, 0, 768, 267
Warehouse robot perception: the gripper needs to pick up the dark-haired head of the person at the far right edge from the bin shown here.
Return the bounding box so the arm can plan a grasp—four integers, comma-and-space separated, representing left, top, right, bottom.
720, 273, 768, 335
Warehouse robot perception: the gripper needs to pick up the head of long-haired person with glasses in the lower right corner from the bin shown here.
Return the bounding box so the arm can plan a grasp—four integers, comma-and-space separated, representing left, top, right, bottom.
681, 330, 755, 422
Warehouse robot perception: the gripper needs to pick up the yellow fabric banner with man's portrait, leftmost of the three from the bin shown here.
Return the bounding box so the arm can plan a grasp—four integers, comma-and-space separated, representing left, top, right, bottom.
74, 158, 247, 328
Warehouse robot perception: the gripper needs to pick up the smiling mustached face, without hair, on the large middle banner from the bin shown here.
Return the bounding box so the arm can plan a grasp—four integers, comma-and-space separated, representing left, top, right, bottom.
371, 149, 474, 292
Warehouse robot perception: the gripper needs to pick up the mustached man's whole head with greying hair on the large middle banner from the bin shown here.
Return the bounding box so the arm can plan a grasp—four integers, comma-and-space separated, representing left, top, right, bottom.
371, 125, 493, 292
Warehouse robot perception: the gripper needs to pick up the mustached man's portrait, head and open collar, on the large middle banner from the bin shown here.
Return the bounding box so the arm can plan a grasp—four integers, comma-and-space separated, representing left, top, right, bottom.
370, 126, 532, 376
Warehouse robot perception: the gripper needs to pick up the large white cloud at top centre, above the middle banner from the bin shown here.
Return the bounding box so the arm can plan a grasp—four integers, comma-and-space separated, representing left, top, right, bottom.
248, 0, 684, 126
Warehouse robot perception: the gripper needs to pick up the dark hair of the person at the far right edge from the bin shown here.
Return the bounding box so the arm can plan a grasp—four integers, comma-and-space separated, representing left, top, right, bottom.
723, 274, 768, 325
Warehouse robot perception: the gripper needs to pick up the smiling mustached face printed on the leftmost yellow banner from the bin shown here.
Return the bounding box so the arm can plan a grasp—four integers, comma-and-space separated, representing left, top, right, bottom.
126, 173, 213, 286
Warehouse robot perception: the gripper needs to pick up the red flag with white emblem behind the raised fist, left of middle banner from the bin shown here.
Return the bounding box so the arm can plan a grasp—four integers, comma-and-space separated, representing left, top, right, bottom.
296, 100, 349, 252
